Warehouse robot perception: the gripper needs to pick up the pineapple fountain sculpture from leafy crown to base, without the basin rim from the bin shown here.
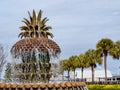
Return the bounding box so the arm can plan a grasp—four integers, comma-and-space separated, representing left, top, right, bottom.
11, 10, 61, 82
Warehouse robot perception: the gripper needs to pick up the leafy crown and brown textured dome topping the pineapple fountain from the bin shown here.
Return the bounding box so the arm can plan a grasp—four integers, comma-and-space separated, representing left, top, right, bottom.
11, 10, 61, 58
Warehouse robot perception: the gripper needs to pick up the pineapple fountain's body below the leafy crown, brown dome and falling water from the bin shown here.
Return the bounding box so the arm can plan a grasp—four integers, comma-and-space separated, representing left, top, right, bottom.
11, 38, 60, 83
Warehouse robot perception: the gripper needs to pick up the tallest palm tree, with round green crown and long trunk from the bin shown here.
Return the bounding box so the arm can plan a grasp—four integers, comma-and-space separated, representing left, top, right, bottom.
96, 38, 114, 83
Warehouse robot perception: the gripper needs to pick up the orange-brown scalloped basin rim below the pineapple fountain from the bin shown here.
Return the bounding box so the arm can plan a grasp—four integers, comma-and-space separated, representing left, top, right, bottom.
0, 82, 88, 90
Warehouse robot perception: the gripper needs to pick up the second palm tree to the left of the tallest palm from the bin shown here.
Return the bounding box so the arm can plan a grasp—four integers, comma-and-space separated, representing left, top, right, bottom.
77, 53, 87, 81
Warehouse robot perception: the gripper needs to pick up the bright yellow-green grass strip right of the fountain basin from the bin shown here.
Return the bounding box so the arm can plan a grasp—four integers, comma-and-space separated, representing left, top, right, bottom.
87, 84, 120, 90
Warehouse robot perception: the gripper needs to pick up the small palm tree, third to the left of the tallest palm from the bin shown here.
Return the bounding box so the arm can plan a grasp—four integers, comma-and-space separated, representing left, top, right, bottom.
69, 56, 78, 81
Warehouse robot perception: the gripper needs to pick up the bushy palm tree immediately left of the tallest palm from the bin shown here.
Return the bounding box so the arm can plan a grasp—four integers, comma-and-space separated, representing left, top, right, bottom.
85, 49, 102, 83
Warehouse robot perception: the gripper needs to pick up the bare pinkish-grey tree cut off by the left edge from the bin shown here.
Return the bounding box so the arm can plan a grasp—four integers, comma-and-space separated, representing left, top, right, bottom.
0, 45, 6, 76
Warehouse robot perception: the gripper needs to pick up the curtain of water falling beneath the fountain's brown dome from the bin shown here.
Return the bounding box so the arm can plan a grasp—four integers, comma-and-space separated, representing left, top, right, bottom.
10, 48, 59, 82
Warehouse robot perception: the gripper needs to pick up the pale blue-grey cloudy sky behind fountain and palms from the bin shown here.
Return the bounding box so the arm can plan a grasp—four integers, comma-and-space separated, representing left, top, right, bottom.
0, 0, 120, 74
